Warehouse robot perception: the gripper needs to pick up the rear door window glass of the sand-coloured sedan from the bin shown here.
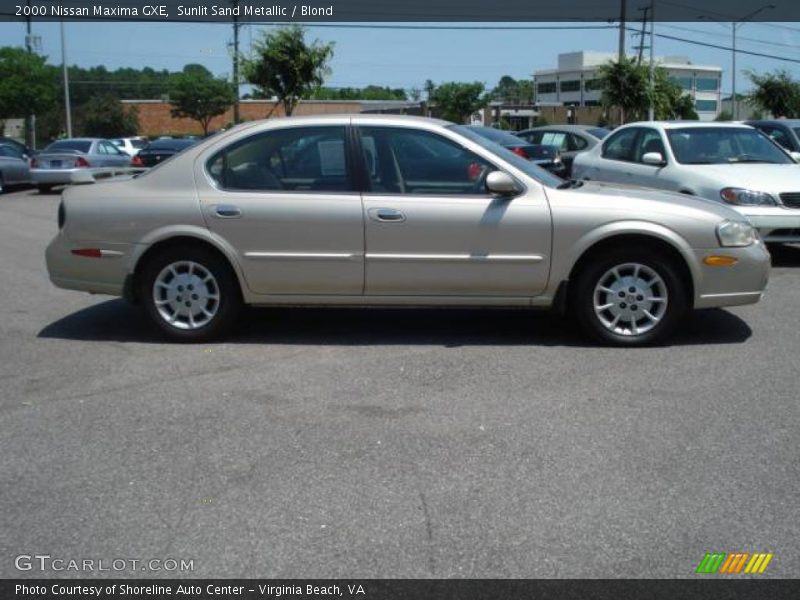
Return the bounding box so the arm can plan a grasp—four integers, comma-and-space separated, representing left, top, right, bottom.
208, 126, 352, 192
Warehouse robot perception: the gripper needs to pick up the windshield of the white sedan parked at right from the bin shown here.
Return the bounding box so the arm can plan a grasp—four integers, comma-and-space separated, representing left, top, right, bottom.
667, 127, 792, 165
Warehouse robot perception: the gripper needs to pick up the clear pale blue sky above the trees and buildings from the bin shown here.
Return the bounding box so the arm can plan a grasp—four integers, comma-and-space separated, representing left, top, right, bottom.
0, 22, 800, 93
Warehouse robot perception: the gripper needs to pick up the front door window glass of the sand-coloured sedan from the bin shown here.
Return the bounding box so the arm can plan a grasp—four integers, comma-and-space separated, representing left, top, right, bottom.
360, 127, 494, 196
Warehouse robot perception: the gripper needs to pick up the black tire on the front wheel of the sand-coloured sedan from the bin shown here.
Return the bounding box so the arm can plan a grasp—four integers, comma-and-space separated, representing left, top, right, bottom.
571, 249, 689, 346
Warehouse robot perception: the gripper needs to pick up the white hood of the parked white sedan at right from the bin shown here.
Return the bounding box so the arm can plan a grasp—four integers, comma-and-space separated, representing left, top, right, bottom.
684, 163, 800, 193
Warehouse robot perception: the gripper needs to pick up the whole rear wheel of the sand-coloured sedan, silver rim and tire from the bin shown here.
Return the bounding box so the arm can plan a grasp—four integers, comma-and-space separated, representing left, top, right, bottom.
138, 247, 242, 342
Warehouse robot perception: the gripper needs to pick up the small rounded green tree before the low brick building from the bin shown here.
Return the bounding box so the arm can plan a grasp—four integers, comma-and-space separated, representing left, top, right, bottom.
169, 65, 236, 135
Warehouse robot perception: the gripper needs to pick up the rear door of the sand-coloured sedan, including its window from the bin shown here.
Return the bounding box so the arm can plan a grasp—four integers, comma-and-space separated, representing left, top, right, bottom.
195, 124, 364, 295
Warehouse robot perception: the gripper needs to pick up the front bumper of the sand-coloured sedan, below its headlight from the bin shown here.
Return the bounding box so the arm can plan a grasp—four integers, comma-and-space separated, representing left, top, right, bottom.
694, 241, 770, 308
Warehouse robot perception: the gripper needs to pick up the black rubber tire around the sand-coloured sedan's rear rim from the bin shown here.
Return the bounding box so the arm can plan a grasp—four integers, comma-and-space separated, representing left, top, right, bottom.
136, 246, 242, 343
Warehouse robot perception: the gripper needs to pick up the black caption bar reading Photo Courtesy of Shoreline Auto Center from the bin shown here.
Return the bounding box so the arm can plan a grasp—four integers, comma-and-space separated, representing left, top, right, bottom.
0, 578, 800, 600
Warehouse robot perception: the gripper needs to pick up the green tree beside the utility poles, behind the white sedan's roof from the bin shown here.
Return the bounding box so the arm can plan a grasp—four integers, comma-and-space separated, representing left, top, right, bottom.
598, 56, 649, 125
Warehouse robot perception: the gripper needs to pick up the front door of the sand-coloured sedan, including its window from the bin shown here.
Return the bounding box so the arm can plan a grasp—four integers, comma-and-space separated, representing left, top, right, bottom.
359, 126, 551, 297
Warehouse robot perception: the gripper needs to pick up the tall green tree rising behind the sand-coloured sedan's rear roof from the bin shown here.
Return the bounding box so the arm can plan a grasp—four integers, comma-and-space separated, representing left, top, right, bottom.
242, 25, 333, 116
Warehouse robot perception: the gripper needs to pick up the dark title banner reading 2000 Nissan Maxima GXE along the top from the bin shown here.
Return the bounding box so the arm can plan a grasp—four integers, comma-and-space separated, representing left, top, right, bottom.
0, 0, 800, 23
